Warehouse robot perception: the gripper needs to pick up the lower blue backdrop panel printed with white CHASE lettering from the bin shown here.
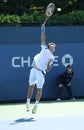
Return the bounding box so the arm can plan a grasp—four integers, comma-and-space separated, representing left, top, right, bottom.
0, 43, 84, 101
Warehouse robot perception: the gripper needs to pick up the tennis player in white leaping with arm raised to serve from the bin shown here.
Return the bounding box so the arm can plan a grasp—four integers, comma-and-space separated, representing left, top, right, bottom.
26, 21, 56, 114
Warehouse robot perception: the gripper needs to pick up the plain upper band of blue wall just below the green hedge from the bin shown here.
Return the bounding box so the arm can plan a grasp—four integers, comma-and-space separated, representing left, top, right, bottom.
0, 26, 84, 44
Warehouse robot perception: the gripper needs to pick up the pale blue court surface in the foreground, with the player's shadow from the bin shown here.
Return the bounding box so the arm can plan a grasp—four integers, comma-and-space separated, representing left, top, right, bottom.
0, 115, 84, 130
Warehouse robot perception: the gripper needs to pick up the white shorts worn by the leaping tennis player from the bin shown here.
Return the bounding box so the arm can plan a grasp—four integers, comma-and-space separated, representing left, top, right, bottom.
29, 68, 45, 88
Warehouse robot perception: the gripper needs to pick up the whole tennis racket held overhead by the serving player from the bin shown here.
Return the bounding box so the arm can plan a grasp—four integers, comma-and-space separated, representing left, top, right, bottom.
43, 3, 55, 25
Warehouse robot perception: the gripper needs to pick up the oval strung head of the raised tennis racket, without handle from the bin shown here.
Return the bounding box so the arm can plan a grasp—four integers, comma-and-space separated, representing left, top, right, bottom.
45, 3, 55, 17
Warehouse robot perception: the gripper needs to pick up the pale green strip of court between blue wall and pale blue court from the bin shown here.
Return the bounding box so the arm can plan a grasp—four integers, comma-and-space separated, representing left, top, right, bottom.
0, 99, 84, 120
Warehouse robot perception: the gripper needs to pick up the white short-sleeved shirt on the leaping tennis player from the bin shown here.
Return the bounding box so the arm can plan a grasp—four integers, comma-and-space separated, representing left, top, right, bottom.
34, 45, 54, 71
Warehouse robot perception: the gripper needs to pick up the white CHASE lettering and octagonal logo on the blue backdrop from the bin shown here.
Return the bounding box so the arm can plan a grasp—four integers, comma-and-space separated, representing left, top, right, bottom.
11, 54, 73, 68
